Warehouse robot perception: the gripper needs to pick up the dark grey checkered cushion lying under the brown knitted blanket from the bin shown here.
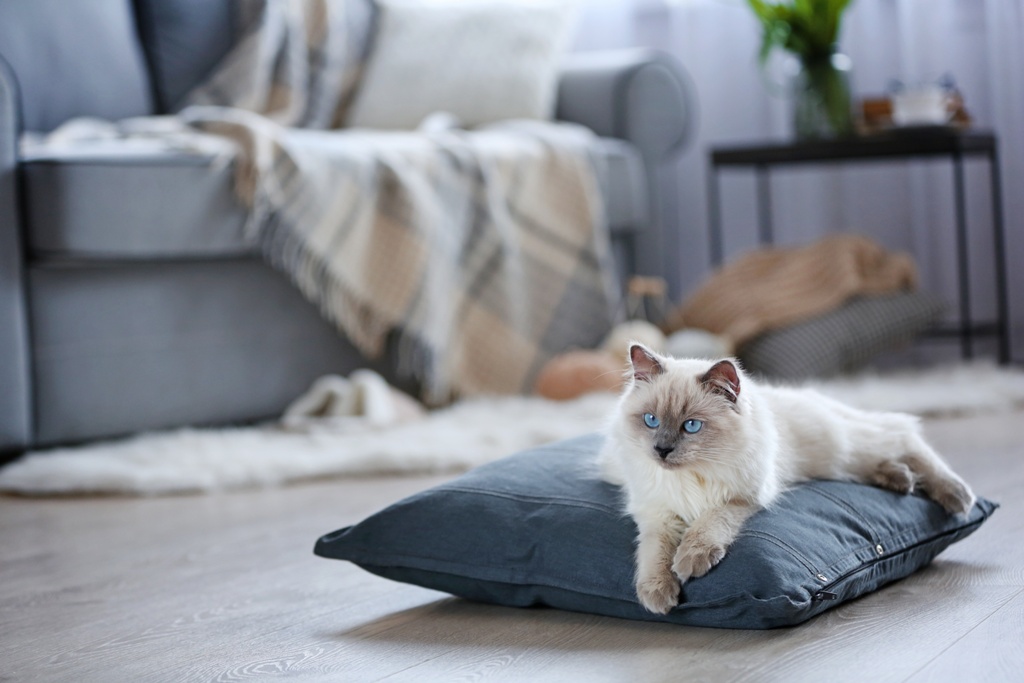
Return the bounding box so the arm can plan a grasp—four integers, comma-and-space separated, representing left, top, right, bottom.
738, 292, 945, 380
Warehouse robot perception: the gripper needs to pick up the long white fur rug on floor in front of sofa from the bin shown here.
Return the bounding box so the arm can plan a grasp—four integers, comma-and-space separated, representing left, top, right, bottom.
0, 362, 1024, 496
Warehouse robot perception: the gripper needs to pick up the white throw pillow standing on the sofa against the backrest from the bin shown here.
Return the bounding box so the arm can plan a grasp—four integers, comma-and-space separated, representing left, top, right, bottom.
346, 0, 574, 130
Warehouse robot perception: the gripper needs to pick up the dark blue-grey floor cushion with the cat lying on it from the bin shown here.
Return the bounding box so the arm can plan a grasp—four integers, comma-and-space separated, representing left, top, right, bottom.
315, 435, 996, 629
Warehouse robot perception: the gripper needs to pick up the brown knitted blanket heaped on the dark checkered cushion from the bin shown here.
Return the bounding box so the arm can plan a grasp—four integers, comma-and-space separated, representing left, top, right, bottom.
673, 234, 918, 346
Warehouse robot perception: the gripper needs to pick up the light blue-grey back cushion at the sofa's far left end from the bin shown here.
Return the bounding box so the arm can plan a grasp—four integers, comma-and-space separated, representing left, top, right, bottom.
0, 0, 153, 131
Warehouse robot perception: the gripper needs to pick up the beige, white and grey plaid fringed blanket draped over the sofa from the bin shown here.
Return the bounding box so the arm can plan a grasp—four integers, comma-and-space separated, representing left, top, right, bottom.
180, 0, 617, 403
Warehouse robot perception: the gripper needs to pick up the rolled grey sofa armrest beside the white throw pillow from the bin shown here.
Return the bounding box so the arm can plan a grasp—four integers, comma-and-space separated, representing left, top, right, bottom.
556, 49, 697, 166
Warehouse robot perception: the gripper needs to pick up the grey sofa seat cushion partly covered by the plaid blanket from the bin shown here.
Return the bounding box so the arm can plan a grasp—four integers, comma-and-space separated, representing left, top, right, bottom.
24, 131, 648, 260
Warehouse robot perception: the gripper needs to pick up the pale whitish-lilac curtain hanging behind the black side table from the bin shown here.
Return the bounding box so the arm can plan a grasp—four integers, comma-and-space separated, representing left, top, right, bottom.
575, 0, 1024, 358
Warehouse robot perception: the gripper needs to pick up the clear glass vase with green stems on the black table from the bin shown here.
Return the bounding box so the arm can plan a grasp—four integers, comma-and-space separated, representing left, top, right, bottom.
793, 52, 854, 139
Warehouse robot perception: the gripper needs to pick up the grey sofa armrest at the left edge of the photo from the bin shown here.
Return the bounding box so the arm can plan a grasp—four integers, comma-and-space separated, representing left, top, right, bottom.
0, 57, 32, 453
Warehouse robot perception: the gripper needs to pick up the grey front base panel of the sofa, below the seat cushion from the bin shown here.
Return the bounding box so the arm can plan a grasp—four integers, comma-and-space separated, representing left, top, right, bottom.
28, 259, 380, 447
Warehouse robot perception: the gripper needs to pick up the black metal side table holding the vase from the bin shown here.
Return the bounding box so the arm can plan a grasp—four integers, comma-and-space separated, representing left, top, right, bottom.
708, 127, 1010, 364
